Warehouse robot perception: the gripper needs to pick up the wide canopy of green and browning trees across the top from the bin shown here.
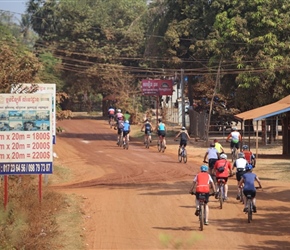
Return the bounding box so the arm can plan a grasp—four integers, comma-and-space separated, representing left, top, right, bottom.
0, 0, 290, 111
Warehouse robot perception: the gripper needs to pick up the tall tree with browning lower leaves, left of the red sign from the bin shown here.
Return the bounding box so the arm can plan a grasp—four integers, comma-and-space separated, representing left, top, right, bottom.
28, 0, 146, 111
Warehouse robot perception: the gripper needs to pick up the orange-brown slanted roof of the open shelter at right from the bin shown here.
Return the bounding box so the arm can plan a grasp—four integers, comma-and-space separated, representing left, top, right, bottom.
235, 95, 290, 121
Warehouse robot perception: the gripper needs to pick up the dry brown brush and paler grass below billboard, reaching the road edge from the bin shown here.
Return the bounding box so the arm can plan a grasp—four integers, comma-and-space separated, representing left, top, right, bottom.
0, 172, 85, 250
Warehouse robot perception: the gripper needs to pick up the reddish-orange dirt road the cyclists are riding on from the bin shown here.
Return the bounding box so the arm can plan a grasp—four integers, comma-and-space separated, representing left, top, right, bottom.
54, 119, 290, 250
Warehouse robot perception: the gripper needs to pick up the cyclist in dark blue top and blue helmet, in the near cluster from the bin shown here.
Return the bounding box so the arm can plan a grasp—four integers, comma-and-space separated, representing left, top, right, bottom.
239, 164, 262, 213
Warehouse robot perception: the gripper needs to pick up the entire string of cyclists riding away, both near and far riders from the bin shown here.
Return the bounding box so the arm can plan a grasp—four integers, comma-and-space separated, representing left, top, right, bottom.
108, 107, 262, 225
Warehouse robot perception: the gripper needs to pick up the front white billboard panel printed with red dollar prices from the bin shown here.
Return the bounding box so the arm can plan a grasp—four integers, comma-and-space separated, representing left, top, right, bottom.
0, 94, 53, 175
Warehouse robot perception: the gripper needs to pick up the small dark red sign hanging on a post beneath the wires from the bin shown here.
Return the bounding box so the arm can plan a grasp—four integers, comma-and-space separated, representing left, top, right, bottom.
142, 79, 173, 96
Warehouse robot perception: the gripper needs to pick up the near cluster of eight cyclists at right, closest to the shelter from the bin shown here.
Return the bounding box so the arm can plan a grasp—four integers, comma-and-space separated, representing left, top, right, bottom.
189, 128, 262, 225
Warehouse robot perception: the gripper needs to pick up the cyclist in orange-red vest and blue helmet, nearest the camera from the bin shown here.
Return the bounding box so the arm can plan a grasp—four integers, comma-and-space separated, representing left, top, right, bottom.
189, 165, 216, 225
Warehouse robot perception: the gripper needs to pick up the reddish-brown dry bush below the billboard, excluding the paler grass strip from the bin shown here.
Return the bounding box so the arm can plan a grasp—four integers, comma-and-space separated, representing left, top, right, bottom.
0, 176, 64, 250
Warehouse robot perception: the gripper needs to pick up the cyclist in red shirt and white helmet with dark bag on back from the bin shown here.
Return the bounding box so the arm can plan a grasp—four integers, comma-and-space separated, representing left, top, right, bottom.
213, 154, 232, 200
